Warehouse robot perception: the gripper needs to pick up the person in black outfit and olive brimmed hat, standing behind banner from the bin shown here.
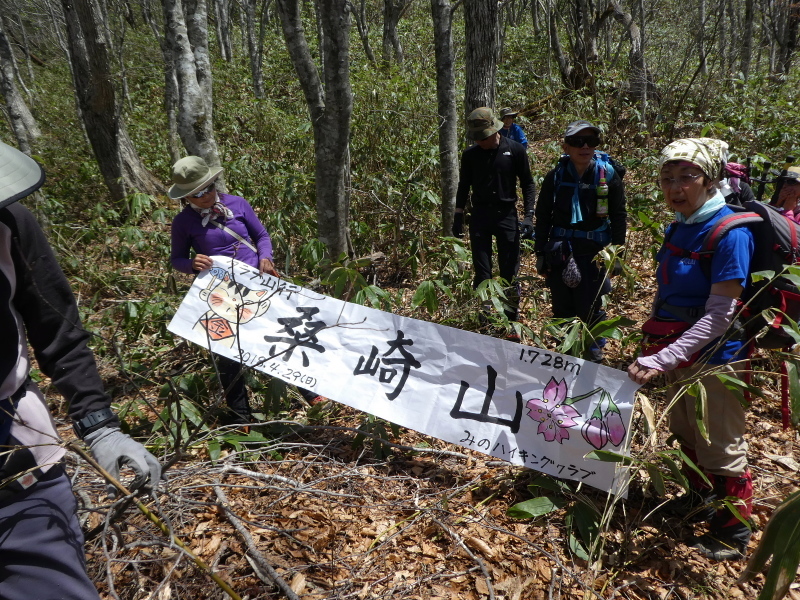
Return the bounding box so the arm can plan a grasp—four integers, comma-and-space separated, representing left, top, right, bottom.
453, 107, 536, 321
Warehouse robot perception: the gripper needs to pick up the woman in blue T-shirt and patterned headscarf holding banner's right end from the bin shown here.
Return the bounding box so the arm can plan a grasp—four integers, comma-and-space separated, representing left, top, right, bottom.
628, 138, 754, 560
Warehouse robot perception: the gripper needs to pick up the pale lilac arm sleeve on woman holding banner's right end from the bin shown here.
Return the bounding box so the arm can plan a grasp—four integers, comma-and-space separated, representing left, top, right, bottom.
636, 294, 738, 371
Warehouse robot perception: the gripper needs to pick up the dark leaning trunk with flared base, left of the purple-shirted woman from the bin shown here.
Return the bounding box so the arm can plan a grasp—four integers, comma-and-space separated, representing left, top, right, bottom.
62, 0, 164, 202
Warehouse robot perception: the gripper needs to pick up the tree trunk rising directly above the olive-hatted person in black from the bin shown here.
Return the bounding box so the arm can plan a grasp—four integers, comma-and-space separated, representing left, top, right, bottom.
464, 0, 499, 115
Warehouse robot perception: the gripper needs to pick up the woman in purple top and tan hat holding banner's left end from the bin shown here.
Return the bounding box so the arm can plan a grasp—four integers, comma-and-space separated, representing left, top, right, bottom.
169, 156, 325, 424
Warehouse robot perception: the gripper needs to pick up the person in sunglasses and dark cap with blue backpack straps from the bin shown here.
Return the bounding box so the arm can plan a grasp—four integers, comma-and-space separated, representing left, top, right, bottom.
534, 120, 627, 362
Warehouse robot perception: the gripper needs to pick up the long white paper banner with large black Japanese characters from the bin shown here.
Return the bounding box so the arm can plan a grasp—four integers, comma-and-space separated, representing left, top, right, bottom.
169, 256, 638, 493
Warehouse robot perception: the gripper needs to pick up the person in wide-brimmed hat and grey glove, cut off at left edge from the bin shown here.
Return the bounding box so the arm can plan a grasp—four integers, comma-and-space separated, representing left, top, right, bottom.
0, 142, 161, 600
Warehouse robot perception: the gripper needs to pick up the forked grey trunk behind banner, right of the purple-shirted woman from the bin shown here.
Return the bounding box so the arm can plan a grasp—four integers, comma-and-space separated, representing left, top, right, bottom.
277, 0, 353, 260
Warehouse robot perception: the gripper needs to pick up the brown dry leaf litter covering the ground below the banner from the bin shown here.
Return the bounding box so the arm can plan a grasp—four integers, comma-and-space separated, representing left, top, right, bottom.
50, 227, 800, 600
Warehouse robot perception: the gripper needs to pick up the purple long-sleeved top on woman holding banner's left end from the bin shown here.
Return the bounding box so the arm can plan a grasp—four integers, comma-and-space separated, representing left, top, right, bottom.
170, 194, 272, 275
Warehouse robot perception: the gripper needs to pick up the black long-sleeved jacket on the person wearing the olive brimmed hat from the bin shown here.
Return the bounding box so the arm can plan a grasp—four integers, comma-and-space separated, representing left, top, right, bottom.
456, 136, 536, 214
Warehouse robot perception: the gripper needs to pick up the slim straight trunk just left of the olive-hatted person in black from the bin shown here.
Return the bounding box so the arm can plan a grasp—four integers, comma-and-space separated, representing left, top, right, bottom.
431, 0, 458, 235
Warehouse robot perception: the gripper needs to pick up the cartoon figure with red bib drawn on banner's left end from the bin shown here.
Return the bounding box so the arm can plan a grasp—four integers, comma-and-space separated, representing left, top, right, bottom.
194, 267, 270, 348
